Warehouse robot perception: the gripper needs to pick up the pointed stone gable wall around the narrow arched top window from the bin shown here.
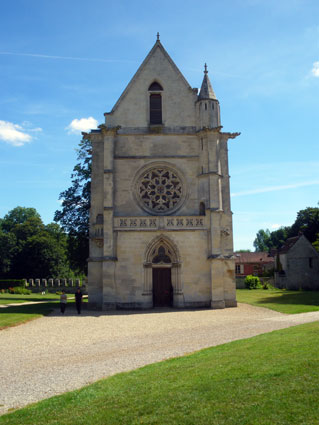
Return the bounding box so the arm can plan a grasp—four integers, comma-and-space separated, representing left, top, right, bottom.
105, 40, 197, 127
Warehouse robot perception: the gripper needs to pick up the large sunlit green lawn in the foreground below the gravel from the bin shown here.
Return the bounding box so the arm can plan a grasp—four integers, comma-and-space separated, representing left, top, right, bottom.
0, 322, 319, 425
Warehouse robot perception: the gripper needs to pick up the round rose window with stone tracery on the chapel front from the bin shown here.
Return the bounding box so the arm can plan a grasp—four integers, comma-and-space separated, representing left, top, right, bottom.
137, 167, 184, 214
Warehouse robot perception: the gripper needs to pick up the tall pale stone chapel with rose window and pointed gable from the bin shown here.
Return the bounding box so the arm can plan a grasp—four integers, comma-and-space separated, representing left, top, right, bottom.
84, 37, 239, 309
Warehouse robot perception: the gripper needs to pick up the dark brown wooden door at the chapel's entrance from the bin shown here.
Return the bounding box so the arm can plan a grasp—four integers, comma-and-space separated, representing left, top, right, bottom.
153, 267, 173, 307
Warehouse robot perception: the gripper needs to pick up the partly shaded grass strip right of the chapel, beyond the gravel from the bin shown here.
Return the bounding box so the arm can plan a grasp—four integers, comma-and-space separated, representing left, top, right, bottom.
236, 289, 319, 314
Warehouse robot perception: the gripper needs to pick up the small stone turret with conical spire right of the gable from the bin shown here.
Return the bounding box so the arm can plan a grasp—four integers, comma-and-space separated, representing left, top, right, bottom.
197, 63, 220, 129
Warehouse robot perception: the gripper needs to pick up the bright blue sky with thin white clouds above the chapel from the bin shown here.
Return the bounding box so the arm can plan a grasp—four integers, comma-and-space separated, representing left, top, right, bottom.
0, 0, 319, 249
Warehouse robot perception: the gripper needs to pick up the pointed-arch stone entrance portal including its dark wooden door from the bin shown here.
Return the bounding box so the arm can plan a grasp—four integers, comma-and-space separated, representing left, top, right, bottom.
143, 235, 184, 307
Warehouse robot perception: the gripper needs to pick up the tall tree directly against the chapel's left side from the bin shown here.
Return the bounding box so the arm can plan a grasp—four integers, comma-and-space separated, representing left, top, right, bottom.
54, 137, 92, 273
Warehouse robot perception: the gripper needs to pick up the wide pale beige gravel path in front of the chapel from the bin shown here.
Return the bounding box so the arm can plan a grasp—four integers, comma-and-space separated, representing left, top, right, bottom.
0, 304, 319, 414
